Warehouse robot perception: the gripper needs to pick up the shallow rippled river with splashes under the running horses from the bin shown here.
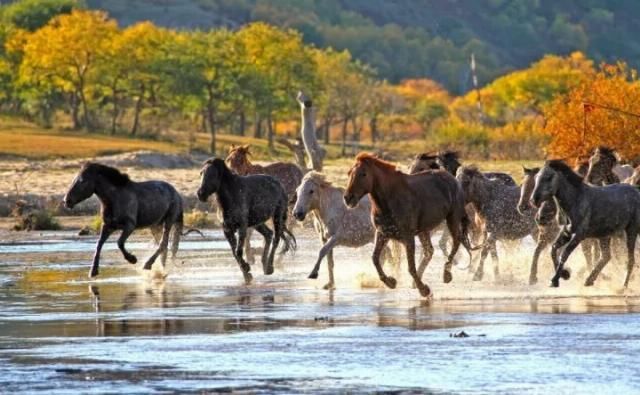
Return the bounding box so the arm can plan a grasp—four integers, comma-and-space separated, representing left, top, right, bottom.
0, 231, 640, 394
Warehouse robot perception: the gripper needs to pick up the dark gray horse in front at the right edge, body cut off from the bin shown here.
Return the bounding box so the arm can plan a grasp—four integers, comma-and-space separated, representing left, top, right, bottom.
531, 160, 640, 287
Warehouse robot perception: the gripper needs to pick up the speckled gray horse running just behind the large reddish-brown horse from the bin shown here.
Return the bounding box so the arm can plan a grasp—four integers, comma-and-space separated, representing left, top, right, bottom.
456, 166, 538, 281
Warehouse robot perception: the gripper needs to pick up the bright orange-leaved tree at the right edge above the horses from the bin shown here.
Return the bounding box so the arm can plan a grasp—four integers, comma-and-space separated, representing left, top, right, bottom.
544, 62, 640, 159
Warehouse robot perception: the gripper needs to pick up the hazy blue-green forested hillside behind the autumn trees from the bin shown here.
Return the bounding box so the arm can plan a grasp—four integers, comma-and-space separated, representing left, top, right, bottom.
86, 0, 640, 93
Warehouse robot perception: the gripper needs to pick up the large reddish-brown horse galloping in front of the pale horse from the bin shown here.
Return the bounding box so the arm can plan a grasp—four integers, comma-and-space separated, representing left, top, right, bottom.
344, 153, 471, 297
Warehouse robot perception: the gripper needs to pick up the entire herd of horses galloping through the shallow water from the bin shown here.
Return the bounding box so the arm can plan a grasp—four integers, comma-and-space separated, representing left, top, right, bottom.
64, 146, 640, 297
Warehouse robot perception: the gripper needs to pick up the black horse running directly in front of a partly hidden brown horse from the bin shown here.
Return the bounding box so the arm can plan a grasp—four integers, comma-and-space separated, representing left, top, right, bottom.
198, 158, 295, 284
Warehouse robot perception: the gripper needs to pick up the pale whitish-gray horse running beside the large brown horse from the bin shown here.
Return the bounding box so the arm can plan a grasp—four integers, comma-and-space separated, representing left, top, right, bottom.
293, 171, 398, 289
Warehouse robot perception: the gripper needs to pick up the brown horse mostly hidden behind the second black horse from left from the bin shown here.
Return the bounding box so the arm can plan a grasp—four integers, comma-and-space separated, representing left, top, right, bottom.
225, 145, 304, 200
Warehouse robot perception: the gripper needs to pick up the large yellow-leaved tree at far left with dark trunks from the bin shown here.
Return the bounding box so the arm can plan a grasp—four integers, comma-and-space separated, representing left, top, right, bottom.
20, 10, 118, 128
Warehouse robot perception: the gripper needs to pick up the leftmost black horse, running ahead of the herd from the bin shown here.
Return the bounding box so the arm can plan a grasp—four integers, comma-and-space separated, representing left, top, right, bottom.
64, 163, 183, 277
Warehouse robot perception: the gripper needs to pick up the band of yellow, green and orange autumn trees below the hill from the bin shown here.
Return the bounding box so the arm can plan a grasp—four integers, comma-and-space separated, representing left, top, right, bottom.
0, 0, 640, 159
